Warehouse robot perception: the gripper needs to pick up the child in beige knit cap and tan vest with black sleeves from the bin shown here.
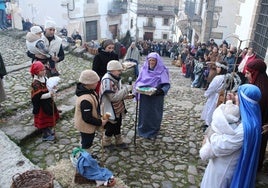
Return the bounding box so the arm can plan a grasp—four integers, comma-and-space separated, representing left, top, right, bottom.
74, 70, 108, 153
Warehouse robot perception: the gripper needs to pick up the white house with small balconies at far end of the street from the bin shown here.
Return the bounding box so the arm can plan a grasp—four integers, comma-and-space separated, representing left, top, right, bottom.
137, 0, 179, 41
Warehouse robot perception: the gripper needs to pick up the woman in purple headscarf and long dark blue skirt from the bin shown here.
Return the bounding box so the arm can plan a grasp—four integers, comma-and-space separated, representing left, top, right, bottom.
134, 52, 170, 139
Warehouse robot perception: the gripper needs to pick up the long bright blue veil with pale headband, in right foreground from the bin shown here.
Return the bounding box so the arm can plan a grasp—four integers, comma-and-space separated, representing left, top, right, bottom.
231, 84, 261, 188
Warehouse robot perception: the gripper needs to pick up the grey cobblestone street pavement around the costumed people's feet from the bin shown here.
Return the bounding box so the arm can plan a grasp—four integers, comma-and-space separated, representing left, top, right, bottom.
0, 30, 268, 188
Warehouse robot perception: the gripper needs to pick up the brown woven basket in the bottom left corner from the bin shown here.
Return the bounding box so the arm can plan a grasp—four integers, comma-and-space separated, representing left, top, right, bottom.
11, 170, 54, 188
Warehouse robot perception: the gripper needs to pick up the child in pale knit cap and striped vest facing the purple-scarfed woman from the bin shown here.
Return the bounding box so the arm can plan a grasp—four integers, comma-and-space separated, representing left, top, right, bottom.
101, 60, 132, 149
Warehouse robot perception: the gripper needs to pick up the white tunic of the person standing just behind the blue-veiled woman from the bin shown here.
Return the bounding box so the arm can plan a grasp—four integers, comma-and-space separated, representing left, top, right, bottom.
201, 75, 224, 126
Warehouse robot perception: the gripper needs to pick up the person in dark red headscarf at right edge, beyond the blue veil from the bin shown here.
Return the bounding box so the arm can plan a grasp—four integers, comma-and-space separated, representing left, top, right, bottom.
245, 59, 268, 171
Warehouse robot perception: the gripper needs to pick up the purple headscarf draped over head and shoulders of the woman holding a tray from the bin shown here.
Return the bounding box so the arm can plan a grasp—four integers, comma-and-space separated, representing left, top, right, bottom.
134, 52, 170, 89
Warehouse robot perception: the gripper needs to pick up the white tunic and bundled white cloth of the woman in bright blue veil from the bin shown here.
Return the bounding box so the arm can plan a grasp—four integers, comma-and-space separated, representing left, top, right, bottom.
199, 106, 244, 188
